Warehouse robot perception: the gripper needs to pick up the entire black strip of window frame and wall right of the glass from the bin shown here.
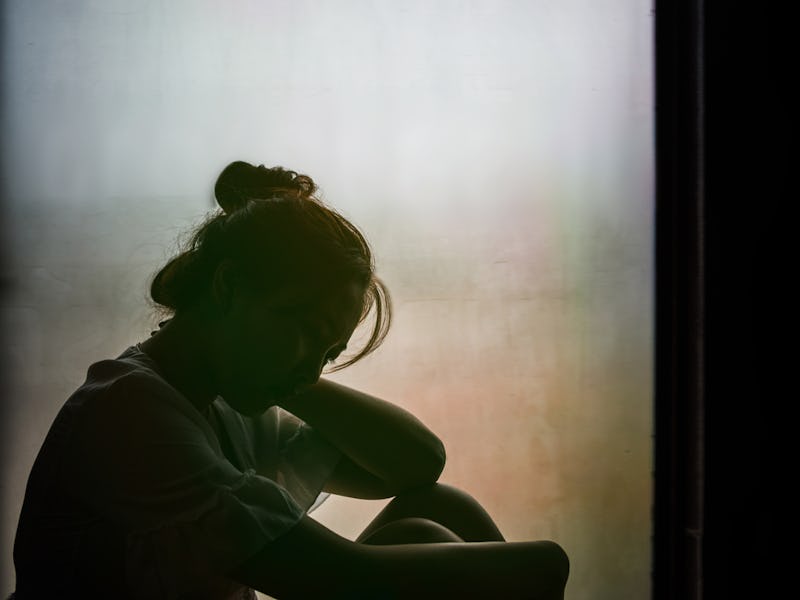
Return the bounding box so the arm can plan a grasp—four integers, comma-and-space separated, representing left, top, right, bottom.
654, 1, 797, 598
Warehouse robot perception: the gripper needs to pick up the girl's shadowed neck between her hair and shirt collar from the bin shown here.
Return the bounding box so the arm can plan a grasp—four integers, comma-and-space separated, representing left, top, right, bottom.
139, 315, 217, 412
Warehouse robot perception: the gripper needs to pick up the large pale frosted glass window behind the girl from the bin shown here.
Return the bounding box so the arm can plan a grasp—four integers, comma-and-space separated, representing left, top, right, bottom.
0, 0, 654, 600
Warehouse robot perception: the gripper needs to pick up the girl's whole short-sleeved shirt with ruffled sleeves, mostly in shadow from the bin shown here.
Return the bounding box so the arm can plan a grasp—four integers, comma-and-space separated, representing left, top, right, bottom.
14, 346, 340, 600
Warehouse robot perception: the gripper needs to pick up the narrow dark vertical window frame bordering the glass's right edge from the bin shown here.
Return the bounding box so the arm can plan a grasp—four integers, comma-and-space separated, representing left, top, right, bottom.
652, 0, 704, 600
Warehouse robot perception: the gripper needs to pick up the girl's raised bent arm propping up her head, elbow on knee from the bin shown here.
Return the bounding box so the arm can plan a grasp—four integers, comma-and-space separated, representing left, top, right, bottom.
282, 379, 445, 489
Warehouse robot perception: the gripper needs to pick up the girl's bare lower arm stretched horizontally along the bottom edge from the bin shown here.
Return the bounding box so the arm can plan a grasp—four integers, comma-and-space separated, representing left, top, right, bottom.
231, 516, 569, 600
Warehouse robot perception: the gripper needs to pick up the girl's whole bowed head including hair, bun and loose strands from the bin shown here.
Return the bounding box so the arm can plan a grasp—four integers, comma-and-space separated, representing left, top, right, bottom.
150, 162, 391, 412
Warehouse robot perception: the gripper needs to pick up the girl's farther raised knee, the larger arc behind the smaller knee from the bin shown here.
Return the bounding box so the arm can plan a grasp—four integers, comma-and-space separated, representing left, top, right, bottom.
356, 483, 505, 543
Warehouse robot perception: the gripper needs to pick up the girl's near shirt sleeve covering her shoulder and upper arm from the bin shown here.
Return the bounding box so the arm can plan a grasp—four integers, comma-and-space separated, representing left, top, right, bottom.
62, 372, 306, 598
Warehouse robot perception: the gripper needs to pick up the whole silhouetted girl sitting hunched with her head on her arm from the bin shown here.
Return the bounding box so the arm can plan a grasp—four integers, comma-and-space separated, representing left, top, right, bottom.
9, 162, 568, 600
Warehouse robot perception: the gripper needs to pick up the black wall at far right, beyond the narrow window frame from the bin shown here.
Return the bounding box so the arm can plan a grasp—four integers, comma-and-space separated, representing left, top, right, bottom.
703, 2, 800, 598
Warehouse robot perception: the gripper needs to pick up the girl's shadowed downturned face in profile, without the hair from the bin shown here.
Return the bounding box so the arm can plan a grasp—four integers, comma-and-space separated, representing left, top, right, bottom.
212, 284, 364, 416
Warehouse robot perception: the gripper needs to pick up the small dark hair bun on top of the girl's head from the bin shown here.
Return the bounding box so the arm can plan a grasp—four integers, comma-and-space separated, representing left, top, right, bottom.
214, 160, 316, 214
